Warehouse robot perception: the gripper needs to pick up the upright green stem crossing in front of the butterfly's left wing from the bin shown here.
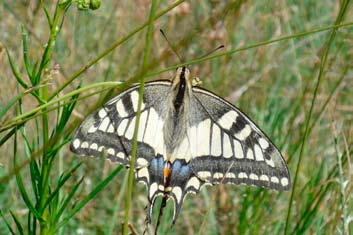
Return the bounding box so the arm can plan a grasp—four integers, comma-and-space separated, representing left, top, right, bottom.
123, 0, 156, 235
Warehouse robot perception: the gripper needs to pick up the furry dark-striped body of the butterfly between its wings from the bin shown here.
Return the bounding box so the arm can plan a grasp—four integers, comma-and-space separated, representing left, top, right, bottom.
163, 67, 192, 162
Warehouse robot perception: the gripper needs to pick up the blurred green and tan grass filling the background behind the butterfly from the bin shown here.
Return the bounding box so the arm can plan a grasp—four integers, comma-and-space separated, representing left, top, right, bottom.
0, 0, 353, 234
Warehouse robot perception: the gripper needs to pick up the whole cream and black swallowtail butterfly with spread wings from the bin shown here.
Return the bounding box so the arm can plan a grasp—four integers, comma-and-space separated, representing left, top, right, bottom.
70, 67, 291, 223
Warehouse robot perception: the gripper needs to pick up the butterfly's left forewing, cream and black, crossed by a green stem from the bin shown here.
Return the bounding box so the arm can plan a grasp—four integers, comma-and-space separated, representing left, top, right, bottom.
70, 81, 170, 168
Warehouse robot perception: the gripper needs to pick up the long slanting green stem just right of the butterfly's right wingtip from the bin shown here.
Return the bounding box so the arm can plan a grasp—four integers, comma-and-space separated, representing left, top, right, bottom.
284, 1, 349, 235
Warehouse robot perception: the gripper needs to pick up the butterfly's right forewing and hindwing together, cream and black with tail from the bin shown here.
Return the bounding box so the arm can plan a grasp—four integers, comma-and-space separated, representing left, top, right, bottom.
151, 87, 290, 222
